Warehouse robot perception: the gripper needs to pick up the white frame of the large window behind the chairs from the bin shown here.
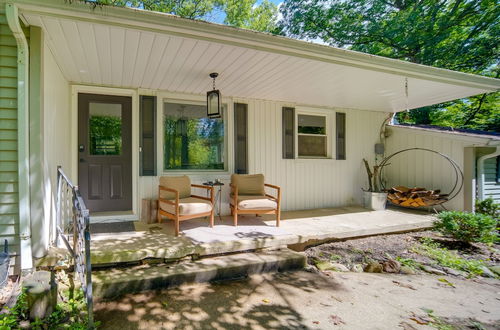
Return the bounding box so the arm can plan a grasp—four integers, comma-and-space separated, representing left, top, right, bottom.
157, 93, 233, 176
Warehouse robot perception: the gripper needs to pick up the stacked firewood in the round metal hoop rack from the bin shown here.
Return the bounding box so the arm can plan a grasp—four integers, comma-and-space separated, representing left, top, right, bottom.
387, 186, 448, 207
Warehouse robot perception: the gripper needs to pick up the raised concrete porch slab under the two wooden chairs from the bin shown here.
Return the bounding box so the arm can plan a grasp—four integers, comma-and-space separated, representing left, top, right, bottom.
91, 206, 433, 265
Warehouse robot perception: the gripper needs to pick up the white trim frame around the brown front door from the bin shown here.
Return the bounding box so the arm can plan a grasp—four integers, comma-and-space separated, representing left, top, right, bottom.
70, 85, 139, 222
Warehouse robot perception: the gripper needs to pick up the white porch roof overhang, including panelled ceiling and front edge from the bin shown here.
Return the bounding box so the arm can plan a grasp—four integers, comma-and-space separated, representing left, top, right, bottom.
15, 0, 500, 112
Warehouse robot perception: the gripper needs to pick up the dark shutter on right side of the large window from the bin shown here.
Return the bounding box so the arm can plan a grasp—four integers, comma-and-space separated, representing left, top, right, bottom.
234, 103, 248, 174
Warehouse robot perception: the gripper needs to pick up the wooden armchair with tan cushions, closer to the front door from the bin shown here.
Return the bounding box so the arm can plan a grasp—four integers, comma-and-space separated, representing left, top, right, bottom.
157, 176, 214, 236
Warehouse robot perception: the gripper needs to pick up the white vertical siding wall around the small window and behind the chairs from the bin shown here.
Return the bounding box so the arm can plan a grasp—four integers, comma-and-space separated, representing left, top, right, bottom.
138, 99, 387, 214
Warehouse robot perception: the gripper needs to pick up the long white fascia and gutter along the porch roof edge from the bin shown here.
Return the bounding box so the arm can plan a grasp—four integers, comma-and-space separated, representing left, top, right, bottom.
14, 0, 500, 92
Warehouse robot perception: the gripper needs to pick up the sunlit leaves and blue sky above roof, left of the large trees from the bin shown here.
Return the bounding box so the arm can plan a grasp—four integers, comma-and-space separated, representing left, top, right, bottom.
88, 0, 278, 32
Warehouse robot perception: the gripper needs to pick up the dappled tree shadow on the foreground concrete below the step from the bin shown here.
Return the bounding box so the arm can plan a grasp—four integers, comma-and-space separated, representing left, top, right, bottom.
95, 272, 343, 329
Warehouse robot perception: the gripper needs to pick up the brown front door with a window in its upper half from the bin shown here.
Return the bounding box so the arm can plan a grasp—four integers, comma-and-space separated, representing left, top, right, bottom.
78, 93, 132, 212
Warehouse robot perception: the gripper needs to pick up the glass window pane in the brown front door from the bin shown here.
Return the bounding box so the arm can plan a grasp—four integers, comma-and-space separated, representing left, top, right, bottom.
89, 102, 122, 155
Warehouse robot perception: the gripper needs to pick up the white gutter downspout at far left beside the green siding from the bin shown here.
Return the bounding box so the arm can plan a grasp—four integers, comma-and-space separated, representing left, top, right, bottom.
5, 3, 33, 272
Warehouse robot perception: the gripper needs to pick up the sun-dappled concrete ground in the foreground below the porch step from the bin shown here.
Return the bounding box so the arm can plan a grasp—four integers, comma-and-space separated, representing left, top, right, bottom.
95, 271, 500, 330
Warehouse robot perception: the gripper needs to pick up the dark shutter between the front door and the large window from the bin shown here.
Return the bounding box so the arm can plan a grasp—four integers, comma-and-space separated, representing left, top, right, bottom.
139, 95, 156, 176
